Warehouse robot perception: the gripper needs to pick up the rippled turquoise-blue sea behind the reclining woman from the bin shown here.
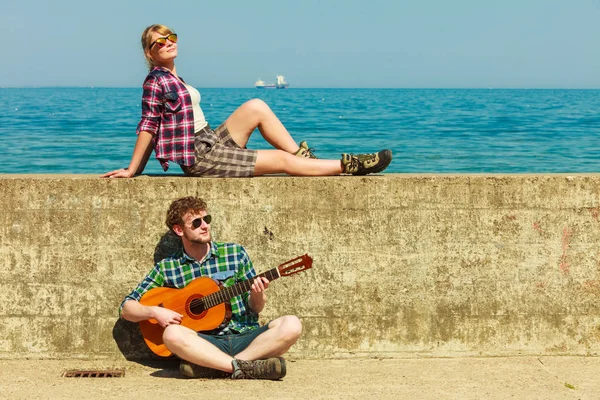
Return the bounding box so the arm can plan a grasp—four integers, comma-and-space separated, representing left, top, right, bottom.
0, 87, 600, 175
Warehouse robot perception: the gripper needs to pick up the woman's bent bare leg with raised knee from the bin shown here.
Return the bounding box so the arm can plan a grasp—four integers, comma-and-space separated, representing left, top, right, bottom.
225, 99, 299, 154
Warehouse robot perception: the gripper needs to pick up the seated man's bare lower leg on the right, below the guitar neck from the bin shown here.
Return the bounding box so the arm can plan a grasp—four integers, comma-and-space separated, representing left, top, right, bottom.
235, 315, 302, 360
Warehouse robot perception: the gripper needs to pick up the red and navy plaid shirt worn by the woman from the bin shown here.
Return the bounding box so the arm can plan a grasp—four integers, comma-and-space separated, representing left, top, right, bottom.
137, 67, 195, 171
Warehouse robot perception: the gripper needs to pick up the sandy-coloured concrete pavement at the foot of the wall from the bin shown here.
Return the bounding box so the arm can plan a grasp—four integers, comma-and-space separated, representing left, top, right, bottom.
0, 357, 600, 399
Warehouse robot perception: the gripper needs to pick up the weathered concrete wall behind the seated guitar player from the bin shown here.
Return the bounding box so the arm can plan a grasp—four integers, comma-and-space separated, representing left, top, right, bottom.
0, 175, 600, 359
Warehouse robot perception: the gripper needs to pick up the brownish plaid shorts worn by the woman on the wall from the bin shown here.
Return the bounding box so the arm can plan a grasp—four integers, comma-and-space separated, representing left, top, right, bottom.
186, 123, 256, 178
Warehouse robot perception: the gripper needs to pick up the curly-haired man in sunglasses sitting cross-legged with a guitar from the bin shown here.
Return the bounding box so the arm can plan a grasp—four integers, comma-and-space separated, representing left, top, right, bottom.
119, 197, 302, 380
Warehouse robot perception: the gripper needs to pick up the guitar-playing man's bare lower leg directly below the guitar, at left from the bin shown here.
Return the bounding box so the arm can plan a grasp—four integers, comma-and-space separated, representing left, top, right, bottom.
163, 325, 233, 373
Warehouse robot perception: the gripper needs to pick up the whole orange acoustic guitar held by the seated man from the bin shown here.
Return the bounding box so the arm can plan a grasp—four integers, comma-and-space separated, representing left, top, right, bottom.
139, 254, 312, 357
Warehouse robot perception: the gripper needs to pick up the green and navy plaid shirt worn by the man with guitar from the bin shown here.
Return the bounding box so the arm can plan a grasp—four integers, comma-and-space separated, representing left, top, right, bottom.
119, 242, 259, 335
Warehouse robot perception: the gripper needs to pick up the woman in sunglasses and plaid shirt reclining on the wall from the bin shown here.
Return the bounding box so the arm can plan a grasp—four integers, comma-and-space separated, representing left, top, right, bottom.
102, 25, 392, 178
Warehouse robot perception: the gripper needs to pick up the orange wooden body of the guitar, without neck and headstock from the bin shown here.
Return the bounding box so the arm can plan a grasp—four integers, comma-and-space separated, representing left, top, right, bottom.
139, 277, 231, 357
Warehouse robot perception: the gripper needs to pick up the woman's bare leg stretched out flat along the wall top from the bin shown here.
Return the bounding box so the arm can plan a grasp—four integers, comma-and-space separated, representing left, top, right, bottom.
254, 150, 343, 176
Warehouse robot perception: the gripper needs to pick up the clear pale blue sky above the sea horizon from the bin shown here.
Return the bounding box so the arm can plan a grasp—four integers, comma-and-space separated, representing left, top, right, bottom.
0, 0, 600, 88
